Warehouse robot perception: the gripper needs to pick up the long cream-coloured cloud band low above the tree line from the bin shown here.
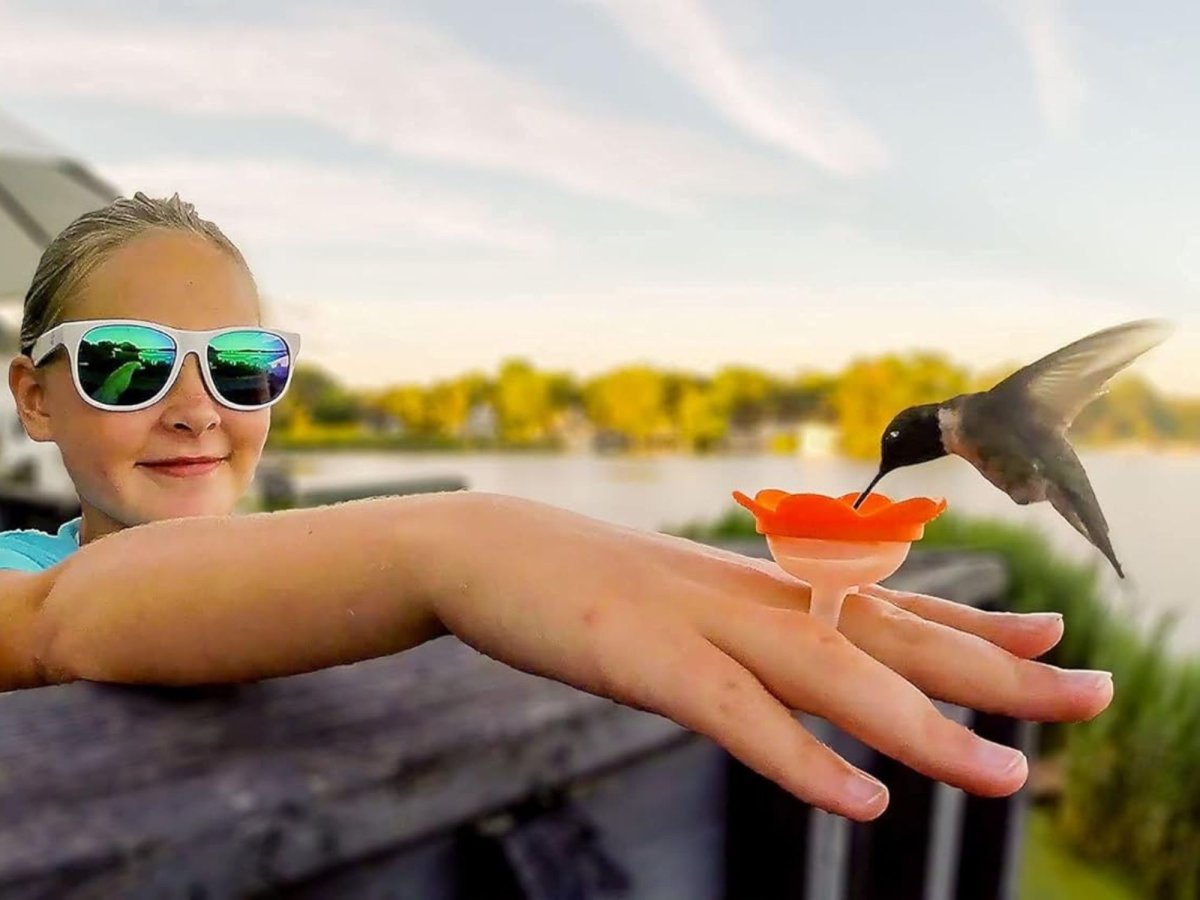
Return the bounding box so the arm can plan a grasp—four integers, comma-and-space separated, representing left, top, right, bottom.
280, 273, 1200, 391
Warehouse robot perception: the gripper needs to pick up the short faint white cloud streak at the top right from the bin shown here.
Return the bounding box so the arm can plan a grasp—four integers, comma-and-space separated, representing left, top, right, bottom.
1002, 0, 1087, 134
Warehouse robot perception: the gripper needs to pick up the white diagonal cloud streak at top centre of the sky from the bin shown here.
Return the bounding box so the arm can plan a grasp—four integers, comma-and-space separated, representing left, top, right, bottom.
588, 0, 888, 175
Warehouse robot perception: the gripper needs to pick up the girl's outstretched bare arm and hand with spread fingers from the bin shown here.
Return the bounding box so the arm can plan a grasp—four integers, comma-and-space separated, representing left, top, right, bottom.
0, 492, 1112, 820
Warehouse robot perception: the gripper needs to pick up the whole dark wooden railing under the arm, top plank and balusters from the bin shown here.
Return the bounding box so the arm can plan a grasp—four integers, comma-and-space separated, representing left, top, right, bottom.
0, 542, 1031, 900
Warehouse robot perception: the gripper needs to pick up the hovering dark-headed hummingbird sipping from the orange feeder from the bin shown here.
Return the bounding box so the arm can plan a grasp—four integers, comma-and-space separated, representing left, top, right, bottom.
854, 319, 1171, 578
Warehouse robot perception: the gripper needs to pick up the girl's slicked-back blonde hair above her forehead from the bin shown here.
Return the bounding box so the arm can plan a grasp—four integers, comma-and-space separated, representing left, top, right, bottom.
20, 191, 250, 355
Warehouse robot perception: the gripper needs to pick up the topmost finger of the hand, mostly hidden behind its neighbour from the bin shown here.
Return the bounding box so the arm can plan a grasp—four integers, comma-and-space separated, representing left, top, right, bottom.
858, 584, 1063, 659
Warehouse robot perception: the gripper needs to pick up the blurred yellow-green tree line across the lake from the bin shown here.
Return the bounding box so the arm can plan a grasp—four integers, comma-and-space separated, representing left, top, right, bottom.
272, 353, 1200, 458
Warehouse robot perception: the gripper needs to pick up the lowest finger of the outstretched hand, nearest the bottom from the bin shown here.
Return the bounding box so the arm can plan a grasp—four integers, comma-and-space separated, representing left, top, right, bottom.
605, 629, 888, 822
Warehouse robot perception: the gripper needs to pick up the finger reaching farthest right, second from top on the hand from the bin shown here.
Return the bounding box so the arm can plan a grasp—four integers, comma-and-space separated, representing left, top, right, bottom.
840, 594, 1112, 721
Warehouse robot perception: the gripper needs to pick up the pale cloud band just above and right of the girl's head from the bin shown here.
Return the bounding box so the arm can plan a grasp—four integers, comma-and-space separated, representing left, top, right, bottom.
96, 157, 553, 253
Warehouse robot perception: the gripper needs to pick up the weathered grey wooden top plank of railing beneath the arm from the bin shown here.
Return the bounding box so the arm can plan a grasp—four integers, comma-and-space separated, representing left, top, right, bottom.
0, 547, 1002, 899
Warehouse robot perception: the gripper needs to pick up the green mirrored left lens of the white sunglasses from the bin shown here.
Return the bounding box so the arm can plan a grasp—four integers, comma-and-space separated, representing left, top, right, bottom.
76, 325, 176, 407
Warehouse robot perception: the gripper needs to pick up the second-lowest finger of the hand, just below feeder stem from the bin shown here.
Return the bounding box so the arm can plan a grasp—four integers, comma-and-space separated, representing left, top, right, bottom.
708, 605, 1028, 797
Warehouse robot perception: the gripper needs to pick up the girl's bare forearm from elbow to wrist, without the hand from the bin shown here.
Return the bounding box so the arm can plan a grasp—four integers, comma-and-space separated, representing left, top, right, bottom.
37, 492, 472, 684
